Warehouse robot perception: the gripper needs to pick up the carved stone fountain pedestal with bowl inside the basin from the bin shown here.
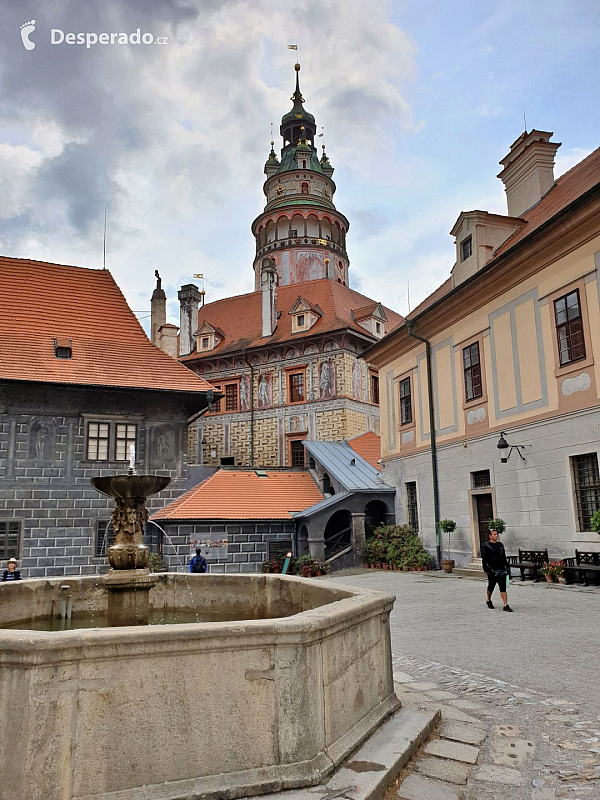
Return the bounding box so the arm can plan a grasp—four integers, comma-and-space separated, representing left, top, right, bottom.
91, 475, 171, 627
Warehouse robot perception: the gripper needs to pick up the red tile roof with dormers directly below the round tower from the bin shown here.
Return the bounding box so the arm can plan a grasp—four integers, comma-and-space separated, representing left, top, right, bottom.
182, 278, 402, 361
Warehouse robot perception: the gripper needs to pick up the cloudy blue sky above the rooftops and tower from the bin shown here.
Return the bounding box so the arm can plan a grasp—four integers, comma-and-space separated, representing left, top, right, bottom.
0, 0, 600, 328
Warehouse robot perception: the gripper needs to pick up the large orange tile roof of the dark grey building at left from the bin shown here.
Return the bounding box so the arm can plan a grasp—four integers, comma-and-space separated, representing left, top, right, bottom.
0, 256, 212, 392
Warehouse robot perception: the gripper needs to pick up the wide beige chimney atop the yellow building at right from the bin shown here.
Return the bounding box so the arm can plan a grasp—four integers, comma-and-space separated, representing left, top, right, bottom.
498, 130, 560, 217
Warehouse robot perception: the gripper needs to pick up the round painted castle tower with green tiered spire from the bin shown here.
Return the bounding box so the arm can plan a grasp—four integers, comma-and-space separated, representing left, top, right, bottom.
252, 64, 350, 291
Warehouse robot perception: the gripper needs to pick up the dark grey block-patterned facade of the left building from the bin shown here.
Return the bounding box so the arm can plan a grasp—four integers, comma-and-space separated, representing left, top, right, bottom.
0, 381, 202, 577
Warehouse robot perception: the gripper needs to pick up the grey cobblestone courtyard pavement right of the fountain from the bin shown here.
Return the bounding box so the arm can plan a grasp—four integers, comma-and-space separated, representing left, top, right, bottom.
328, 572, 600, 800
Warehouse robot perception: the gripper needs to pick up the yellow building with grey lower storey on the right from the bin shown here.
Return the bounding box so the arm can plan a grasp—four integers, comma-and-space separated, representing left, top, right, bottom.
364, 130, 600, 567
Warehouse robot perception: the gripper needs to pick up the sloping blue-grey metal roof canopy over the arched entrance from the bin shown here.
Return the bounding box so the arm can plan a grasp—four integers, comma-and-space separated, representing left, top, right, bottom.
302, 440, 395, 492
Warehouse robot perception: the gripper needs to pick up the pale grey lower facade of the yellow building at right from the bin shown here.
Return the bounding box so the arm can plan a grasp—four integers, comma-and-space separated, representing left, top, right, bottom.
382, 409, 600, 566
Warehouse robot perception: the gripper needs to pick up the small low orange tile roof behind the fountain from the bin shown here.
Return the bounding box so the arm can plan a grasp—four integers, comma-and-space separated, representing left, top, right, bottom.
152, 470, 323, 519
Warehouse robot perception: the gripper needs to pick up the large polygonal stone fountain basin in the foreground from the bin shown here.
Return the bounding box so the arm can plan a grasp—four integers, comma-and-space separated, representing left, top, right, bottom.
0, 574, 399, 800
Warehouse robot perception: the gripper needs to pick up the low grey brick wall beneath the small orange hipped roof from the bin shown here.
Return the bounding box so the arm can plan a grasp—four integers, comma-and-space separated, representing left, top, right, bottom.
159, 520, 296, 573
